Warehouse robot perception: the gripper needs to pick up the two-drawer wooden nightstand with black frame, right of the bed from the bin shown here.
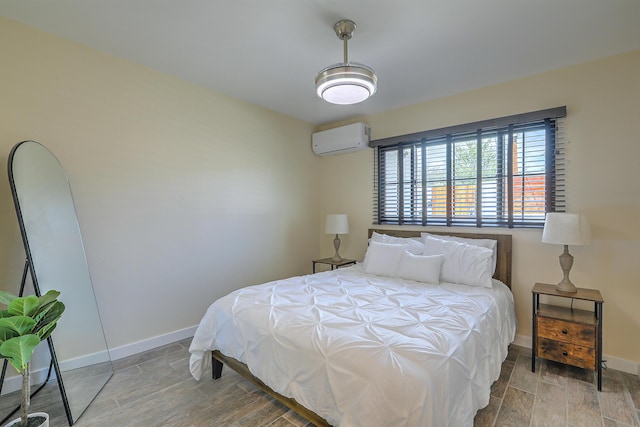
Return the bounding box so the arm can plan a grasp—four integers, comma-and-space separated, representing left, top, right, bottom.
531, 283, 604, 391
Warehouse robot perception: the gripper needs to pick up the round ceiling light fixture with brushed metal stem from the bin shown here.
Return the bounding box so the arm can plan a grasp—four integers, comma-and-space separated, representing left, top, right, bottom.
316, 19, 378, 105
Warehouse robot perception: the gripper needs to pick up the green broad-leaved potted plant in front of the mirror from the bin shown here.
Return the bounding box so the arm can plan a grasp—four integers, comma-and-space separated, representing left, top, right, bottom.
0, 290, 64, 427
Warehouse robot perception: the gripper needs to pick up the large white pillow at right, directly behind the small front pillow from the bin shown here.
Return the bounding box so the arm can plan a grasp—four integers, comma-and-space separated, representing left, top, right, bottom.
423, 236, 493, 288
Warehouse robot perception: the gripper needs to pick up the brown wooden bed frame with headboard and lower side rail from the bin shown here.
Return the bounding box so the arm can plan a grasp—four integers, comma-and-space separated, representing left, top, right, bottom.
211, 228, 511, 427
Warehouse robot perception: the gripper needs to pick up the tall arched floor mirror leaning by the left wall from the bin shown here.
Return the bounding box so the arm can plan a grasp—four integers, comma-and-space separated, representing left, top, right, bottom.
8, 141, 113, 425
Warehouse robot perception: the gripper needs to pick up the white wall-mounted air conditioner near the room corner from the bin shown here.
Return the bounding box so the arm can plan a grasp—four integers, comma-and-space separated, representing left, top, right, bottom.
311, 123, 371, 156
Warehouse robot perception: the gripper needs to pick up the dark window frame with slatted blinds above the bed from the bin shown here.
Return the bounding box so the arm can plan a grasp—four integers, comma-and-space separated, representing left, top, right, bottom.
370, 107, 566, 228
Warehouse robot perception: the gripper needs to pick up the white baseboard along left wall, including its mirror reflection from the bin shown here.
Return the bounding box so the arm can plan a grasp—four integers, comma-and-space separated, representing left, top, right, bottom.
2, 326, 197, 395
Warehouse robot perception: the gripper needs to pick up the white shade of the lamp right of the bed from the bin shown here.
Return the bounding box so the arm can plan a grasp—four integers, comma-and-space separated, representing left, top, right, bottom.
542, 212, 591, 245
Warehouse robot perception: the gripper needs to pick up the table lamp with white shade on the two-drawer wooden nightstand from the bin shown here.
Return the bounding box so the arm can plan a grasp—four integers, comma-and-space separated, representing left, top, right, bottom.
542, 212, 591, 293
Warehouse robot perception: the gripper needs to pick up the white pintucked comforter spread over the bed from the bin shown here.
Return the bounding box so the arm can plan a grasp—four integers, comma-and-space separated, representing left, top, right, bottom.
190, 265, 516, 427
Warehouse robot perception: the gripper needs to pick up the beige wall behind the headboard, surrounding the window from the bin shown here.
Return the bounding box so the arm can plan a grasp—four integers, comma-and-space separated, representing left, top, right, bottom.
321, 51, 640, 369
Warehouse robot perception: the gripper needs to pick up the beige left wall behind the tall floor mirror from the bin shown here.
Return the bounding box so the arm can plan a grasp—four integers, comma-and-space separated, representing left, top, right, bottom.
0, 18, 321, 358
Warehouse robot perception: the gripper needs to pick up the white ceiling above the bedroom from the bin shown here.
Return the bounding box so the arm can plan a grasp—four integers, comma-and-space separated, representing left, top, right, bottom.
0, 0, 640, 124
